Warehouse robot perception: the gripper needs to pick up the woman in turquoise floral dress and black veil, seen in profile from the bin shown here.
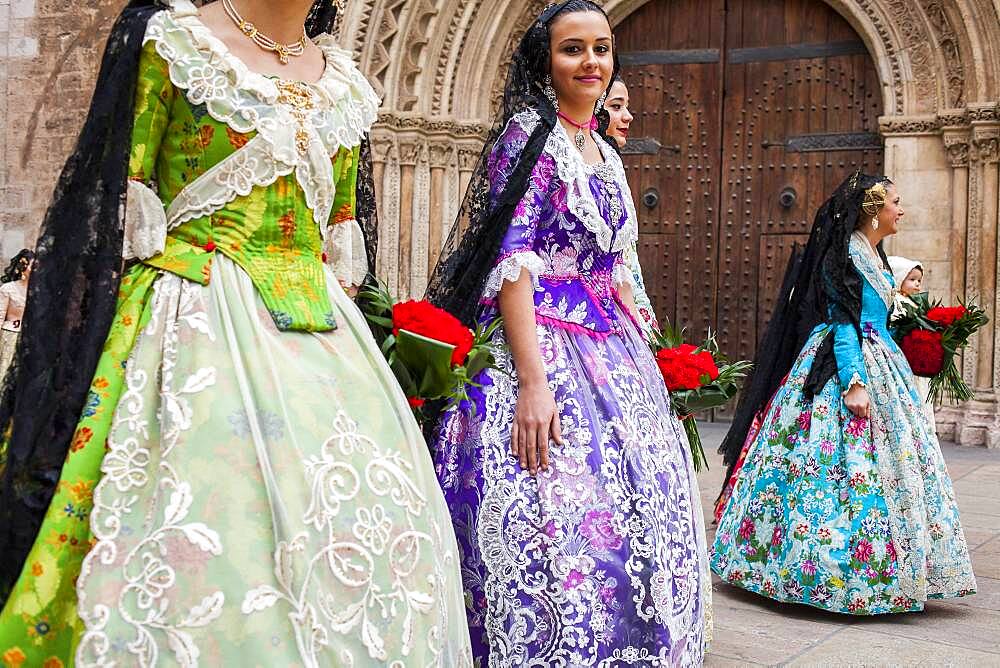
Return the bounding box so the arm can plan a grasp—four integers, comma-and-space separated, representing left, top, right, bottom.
712, 173, 976, 615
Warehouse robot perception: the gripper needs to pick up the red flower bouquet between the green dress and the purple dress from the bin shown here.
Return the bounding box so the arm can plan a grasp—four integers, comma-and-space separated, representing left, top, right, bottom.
358, 283, 500, 421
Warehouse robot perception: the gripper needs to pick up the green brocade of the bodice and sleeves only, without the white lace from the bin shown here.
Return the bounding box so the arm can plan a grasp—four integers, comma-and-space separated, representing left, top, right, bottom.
129, 42, 358, 332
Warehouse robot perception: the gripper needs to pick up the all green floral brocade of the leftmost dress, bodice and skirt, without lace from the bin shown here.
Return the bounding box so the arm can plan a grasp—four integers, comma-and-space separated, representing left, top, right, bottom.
0, 42, 358, 668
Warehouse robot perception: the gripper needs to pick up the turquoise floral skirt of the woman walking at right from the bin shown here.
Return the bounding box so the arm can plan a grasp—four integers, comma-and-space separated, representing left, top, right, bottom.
711, 325, 976, 615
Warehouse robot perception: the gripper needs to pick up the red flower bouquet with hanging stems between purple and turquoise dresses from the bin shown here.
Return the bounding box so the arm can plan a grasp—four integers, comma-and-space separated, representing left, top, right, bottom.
653, 322, 752, 471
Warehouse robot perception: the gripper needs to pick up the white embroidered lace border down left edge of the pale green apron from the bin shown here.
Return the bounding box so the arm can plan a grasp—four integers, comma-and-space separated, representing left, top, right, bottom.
76, 275, 225, 668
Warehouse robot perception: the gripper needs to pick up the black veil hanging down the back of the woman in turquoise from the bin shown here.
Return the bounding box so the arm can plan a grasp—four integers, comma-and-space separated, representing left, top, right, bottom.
719, 172, 890, 481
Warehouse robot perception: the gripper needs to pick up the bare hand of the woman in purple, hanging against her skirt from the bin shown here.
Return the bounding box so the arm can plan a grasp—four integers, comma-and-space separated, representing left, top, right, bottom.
510, 383, 562, 475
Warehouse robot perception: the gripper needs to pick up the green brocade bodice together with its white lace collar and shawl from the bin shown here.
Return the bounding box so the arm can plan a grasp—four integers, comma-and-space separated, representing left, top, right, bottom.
129, 3, 377, 331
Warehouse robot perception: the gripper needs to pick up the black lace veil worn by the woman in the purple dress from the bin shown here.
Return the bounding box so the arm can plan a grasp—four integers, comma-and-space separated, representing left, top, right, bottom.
427, 0, 619, 326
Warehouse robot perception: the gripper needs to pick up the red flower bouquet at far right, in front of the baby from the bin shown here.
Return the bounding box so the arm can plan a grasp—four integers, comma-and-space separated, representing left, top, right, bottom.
893, 293, 989, 404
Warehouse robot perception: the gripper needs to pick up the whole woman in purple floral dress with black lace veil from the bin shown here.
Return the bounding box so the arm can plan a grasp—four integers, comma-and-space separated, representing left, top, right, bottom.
429, 0, 711, 666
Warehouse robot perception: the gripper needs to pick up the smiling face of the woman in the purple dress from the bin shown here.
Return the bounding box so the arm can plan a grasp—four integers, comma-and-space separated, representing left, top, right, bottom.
549, 12, 614, 113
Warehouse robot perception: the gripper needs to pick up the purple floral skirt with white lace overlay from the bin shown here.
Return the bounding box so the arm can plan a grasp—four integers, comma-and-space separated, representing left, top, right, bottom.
435, 313, 711, 666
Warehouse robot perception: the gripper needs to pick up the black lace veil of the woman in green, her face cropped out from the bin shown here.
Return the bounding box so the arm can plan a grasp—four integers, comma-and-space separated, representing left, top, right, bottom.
0, 0, 377, 605
